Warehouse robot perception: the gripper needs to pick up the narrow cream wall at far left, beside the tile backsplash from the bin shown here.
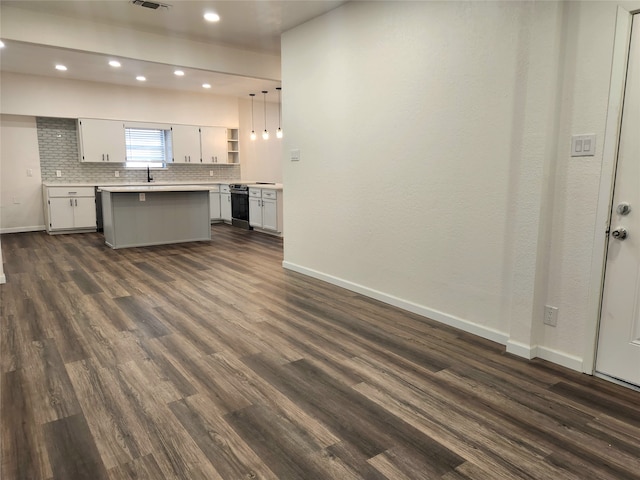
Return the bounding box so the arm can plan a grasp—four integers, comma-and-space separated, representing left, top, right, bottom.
0, 115, 44, 233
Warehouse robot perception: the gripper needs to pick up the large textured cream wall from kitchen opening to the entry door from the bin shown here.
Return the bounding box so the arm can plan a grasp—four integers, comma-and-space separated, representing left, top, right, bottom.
282, 2, 640, 369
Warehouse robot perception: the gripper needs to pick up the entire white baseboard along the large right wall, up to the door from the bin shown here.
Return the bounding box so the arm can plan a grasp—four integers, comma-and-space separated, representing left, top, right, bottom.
282, 261, 582, 372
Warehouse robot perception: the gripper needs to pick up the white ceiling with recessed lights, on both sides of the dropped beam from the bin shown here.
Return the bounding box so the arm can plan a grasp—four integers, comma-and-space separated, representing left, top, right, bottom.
0, 0, 345, 96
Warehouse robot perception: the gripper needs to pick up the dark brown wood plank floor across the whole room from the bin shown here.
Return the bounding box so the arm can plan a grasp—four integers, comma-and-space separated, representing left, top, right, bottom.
0, 225, 640, 480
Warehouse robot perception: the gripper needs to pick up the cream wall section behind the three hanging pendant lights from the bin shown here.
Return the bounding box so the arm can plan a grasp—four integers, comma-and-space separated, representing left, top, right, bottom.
238, 96, 282, 183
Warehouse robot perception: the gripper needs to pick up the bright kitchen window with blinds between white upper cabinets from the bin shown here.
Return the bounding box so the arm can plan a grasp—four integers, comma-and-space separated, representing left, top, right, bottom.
125, 127, 171, 168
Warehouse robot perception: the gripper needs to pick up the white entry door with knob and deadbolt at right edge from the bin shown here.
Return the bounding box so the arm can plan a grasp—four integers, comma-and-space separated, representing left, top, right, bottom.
596, 15, 640, 385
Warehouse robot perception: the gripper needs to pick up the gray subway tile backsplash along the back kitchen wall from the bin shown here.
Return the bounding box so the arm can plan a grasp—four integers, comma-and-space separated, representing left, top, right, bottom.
36, 117, 240, 183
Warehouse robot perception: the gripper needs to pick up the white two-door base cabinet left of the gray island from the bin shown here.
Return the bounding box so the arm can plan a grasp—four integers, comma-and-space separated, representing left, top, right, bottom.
45, 186, 96, 233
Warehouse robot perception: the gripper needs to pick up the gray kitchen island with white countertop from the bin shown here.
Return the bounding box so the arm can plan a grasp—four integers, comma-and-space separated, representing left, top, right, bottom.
99, 185, 211, 248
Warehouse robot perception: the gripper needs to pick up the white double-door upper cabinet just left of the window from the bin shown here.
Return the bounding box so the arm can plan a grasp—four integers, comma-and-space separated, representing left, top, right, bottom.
78, 118, 127, 163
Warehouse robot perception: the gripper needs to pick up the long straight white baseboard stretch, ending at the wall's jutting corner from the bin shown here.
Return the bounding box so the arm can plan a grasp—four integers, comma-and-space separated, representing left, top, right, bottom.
282, 261, 508, 345
